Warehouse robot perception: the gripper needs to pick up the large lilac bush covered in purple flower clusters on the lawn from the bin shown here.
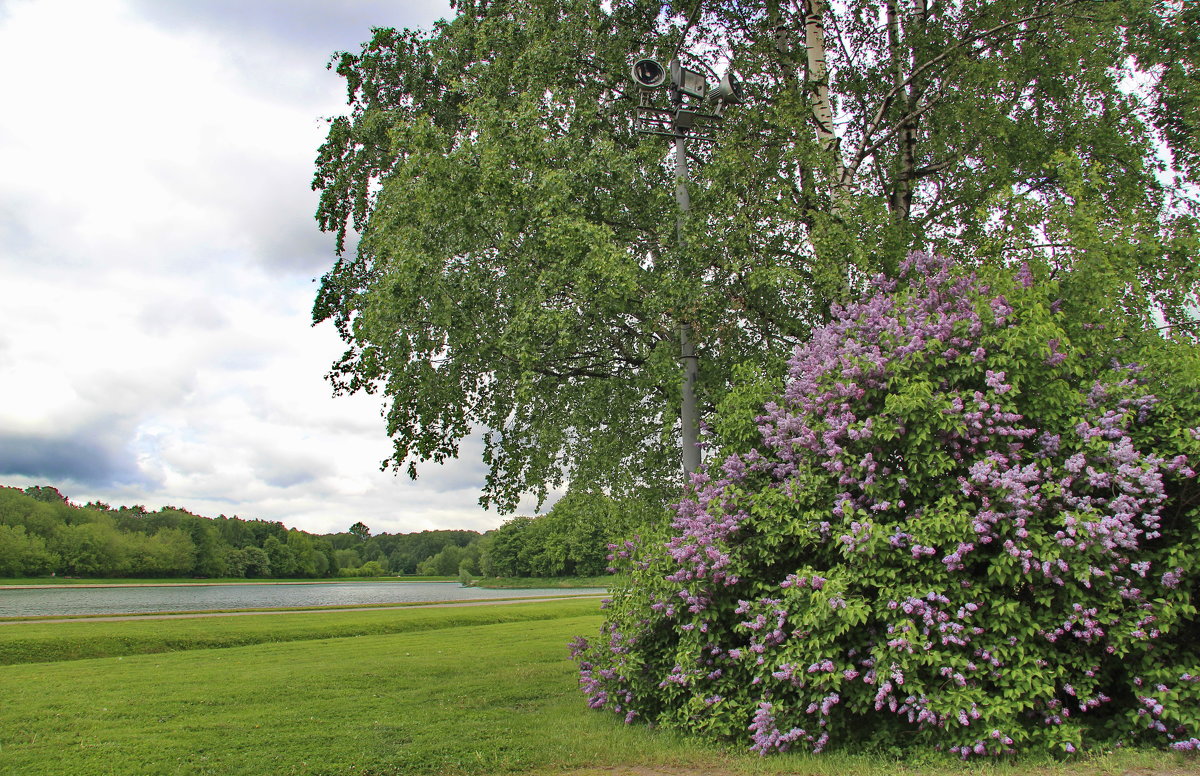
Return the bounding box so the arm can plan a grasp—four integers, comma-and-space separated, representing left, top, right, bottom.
572, 253, 1200, 759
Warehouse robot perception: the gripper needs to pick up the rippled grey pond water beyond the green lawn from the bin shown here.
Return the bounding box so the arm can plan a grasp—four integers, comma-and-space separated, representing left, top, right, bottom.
0, 582, 604, 616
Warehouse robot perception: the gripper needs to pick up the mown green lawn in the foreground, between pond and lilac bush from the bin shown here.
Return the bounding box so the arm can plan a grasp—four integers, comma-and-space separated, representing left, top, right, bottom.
0, 600, 1200, 776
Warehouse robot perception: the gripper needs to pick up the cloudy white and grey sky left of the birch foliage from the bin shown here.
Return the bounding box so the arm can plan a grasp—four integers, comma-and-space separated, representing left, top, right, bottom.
0, 0, 540, 533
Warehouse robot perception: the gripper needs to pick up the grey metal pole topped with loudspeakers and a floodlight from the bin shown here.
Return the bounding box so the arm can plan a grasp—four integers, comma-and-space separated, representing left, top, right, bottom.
632, 59, 742, 477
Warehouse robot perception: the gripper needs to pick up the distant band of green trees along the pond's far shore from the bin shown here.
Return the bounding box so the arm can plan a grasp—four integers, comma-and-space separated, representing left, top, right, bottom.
0, 487, 653, 578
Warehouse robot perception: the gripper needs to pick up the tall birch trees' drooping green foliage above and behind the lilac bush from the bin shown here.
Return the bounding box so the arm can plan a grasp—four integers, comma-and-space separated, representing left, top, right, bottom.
313, 0, 1200, 509
